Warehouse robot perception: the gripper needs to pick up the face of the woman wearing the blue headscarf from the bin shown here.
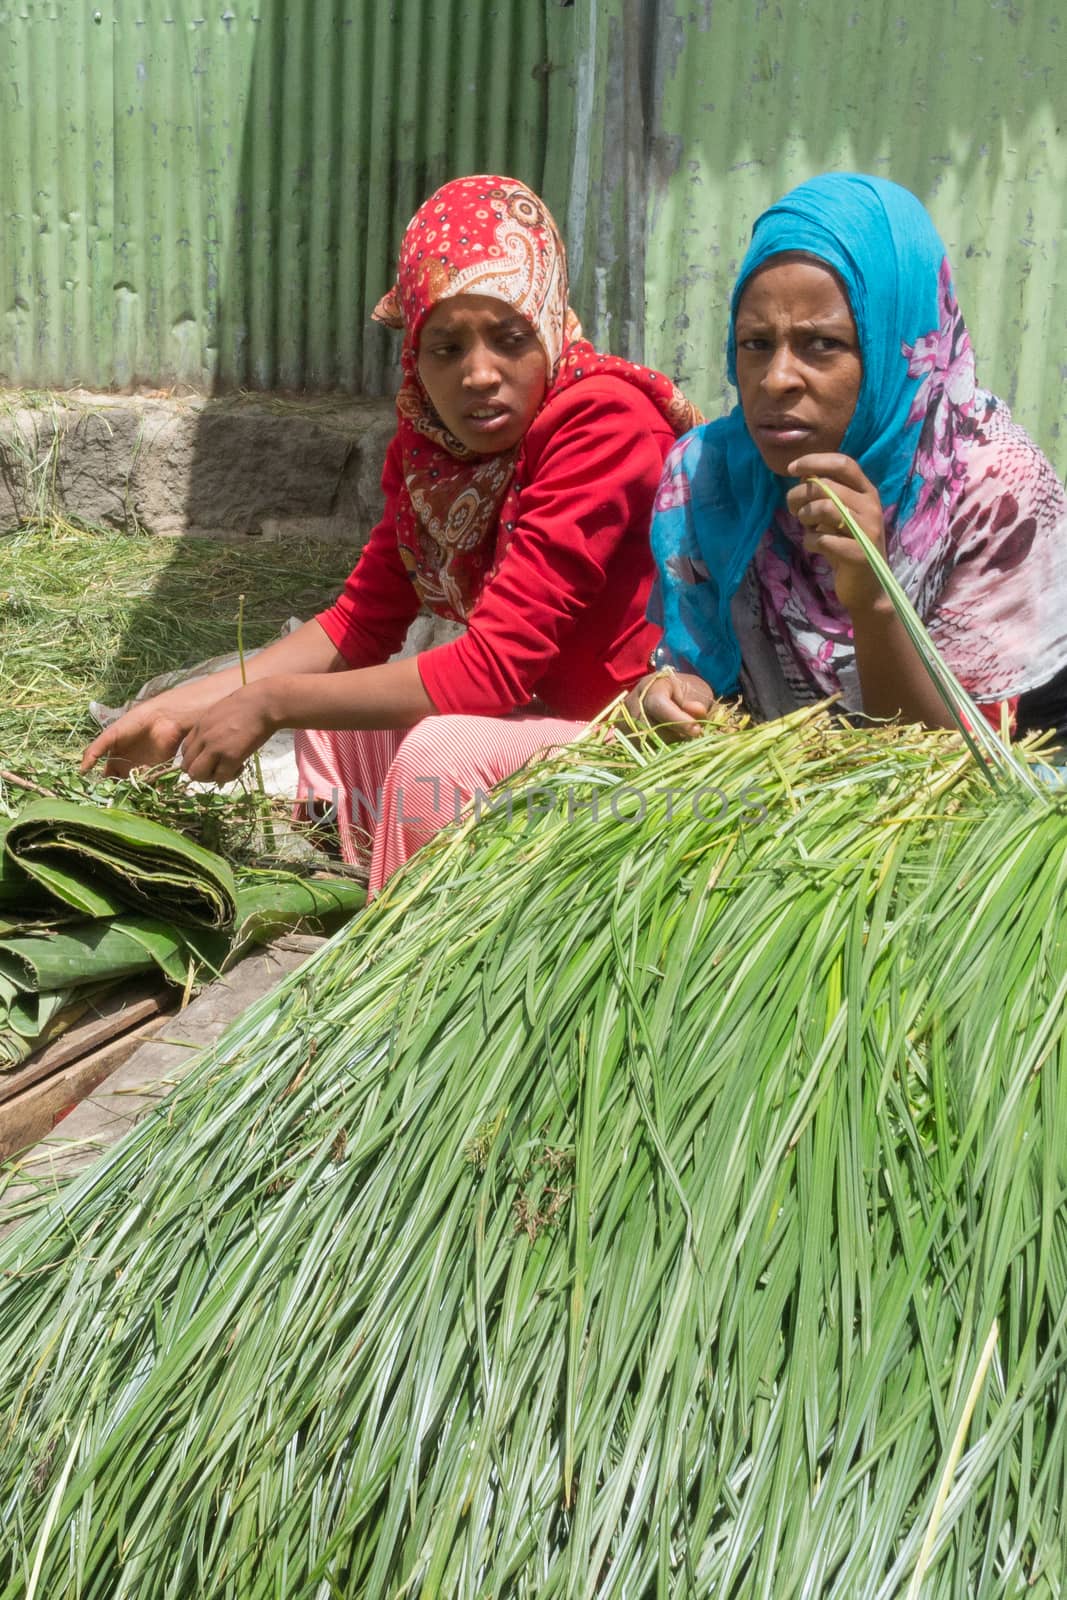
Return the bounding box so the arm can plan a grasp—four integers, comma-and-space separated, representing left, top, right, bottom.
734, 258, 864, 475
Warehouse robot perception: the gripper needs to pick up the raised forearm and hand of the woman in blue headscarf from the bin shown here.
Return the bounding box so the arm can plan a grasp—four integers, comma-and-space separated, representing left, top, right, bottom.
787, 454, 953, 728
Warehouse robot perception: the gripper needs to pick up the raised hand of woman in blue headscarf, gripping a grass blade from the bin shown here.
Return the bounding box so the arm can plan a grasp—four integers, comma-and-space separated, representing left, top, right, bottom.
785, 454, 889, 618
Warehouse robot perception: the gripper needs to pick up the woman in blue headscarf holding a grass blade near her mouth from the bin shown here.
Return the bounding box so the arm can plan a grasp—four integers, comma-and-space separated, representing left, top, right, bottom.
632, 173, 1067, 734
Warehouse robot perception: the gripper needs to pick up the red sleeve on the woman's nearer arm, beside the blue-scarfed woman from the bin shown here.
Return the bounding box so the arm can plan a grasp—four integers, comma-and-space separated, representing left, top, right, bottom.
419, 376, 673, 715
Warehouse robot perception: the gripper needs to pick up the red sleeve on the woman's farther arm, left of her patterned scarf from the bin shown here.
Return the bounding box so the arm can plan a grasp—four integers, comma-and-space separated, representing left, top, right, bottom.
315, 435, 419, 667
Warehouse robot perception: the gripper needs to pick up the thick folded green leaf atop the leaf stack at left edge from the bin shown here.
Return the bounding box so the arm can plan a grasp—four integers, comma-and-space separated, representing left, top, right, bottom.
2, 800, 237, 930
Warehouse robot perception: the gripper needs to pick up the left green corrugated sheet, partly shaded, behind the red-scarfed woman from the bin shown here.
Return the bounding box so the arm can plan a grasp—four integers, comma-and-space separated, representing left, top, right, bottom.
0, 0, 574, 392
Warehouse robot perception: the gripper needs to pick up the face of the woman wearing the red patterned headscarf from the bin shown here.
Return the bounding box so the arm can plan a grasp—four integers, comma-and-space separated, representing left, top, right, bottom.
419, 294, 549, 456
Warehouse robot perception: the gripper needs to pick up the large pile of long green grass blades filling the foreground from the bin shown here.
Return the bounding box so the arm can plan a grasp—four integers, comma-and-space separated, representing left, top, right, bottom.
0, 714, 1067, 1600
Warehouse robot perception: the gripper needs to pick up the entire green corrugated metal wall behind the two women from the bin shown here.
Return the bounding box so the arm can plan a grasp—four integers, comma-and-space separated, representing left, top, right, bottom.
0, 0, 1067, 472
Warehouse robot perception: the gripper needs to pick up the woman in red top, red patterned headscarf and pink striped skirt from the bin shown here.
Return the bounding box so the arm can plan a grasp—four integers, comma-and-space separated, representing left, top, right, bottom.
82, 176, 699, 890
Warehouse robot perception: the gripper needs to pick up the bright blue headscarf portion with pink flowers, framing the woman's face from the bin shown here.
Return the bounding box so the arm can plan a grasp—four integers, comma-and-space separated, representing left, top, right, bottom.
651, 173, 974, 694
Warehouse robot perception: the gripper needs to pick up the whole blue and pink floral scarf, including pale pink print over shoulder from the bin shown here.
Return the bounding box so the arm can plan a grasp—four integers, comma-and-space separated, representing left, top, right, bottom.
653, 173, 1067, 709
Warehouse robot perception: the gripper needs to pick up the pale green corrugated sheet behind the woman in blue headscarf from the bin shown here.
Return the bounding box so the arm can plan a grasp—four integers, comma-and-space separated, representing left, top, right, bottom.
571, 0, 1067, 474
